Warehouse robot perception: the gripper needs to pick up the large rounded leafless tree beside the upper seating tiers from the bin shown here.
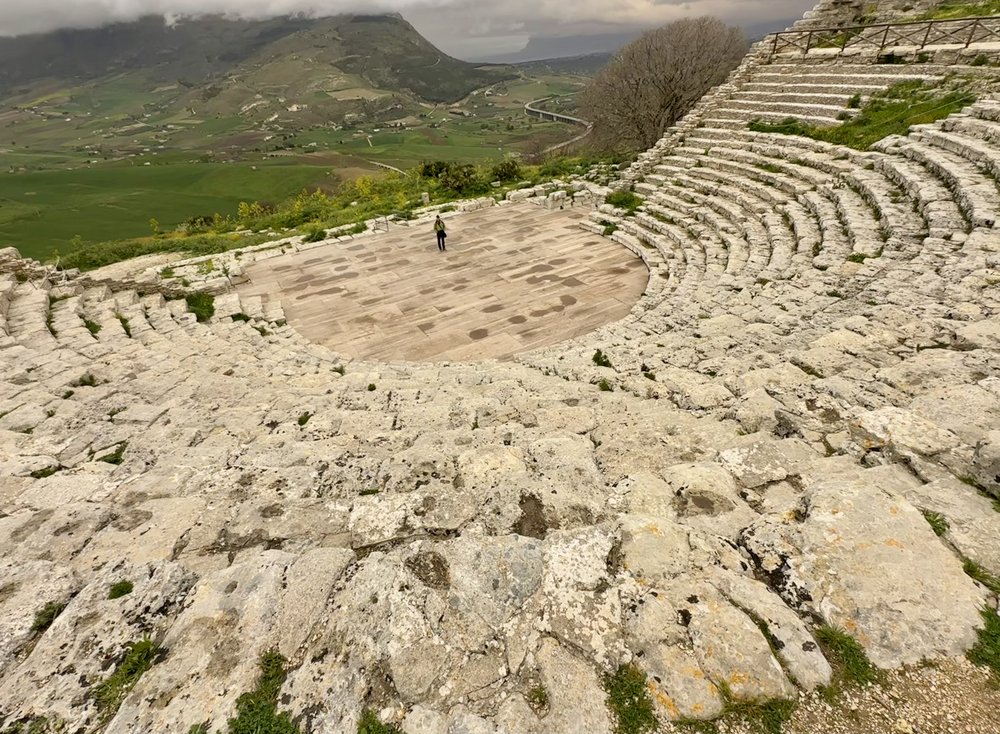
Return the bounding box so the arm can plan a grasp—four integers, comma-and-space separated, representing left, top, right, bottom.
578, 16, 747, 150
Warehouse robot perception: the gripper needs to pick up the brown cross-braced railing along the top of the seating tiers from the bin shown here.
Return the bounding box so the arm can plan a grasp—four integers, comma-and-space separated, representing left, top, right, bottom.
771, 16, 1000, 56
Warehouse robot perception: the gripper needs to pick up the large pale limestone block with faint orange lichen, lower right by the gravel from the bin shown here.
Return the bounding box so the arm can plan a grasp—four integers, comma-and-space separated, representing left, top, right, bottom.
744, 471, 984, 667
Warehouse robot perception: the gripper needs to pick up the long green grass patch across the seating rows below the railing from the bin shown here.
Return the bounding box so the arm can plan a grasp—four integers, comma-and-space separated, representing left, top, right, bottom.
749, 81, 976, 150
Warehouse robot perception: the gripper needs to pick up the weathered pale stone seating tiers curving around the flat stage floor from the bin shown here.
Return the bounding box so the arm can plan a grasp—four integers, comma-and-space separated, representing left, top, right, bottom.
0, 0, 1000, 734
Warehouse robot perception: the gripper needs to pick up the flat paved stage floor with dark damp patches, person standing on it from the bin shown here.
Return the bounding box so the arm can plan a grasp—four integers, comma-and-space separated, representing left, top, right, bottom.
239, 204, 648, 361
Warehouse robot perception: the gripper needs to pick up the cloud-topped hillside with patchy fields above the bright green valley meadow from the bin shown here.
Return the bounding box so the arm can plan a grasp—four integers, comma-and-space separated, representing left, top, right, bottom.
0, 15, 515, 165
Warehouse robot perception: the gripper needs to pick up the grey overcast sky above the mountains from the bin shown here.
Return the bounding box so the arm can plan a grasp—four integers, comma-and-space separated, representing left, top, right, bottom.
0, 0, 816, 57
